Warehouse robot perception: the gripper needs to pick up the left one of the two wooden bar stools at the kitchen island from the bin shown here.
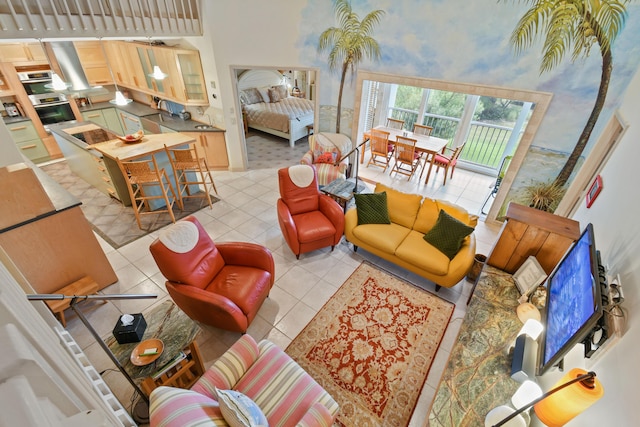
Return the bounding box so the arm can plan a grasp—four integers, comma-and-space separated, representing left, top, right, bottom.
117, 156, 183, 229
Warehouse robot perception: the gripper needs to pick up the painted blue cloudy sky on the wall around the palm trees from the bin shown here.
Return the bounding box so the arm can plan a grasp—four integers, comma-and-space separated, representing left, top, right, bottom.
300, 0, 640, 162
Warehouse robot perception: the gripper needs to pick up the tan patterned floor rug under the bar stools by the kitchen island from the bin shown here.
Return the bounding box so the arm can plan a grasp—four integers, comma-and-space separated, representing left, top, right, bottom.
40, 161, 219, 249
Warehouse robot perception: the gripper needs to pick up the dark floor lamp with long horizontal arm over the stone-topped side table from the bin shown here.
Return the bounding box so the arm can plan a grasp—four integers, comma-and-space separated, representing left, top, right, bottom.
27, 294, 158, 423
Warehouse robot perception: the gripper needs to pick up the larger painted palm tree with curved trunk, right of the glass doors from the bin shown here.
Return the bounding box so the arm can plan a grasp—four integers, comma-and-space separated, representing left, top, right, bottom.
504, 0, 630, 189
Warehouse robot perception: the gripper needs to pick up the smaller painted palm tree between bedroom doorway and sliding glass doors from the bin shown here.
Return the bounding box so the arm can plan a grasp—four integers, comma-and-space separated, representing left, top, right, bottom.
318, 0, 384, 133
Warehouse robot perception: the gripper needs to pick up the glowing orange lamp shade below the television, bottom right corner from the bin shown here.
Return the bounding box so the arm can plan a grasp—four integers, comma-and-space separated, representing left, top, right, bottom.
533, 368, 604, 427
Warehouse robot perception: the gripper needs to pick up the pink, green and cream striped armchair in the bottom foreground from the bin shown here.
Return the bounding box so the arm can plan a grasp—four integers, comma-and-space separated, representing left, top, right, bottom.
149, 334, 338, 427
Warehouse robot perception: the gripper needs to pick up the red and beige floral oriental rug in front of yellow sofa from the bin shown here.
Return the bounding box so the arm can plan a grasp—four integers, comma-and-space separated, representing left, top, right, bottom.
286, 261, 455, 427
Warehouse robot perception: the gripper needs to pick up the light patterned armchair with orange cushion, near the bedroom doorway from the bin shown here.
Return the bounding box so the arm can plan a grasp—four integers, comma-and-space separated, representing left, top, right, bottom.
300, 132, 352, 185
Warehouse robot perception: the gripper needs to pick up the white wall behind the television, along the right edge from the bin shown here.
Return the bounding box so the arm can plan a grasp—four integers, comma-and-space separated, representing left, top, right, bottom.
572, 67, 640, 426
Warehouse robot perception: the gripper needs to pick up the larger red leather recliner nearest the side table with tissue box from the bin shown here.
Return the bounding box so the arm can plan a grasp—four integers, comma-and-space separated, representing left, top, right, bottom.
150, 216, 275, 333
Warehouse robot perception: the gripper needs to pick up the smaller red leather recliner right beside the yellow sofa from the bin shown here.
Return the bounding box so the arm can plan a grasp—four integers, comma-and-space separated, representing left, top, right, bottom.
278, 165, 344, 258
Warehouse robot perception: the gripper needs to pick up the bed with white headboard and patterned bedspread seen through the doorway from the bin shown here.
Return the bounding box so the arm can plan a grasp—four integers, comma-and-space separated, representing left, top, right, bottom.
238, 70, 314, 147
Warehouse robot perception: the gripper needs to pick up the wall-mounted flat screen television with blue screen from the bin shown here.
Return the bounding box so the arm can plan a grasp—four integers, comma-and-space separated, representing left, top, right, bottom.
536, 224, 602, 375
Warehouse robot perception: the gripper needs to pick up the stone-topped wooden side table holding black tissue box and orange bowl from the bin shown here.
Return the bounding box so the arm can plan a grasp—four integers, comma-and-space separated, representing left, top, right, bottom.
105, 301, 204, 396
